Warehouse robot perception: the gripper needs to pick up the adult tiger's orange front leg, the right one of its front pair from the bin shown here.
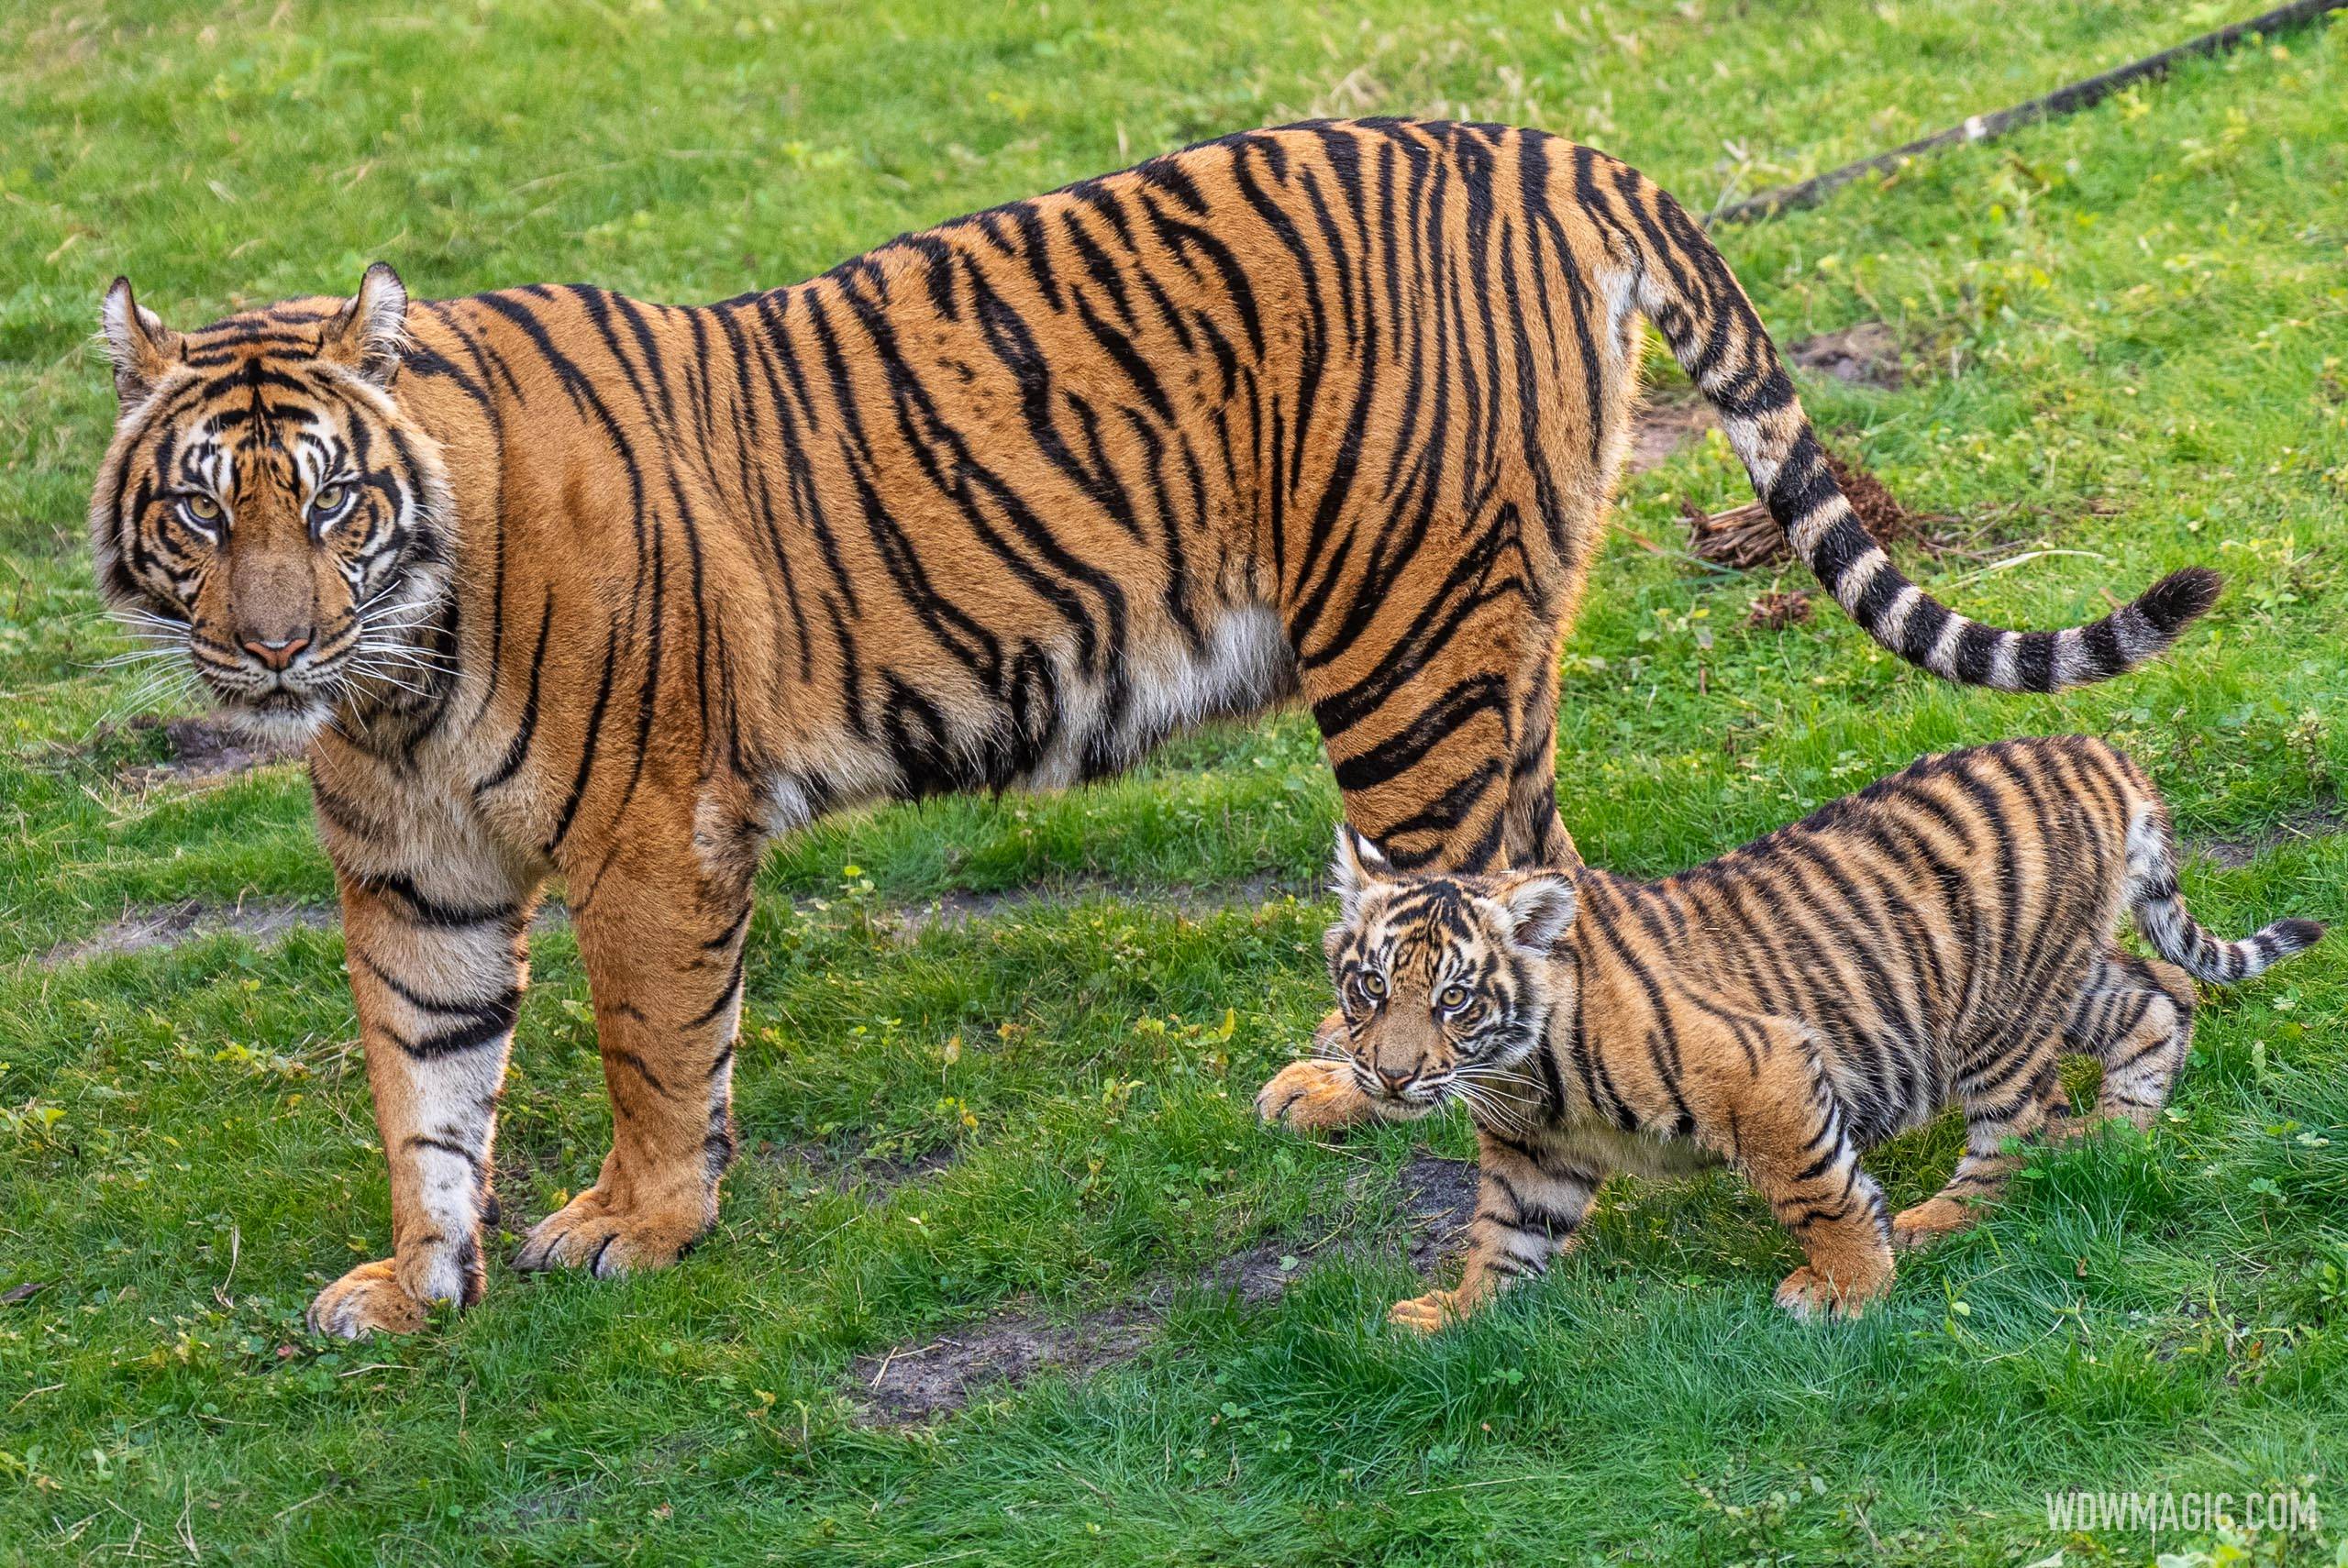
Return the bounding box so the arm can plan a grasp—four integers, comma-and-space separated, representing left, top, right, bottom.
515, 845, 756, 1279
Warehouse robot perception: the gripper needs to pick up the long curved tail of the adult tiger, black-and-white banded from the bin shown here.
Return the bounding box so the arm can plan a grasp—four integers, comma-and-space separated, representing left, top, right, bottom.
1613, 169, 2219, 692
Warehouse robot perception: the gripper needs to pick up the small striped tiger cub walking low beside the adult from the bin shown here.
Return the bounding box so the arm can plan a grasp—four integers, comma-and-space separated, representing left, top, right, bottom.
1326, 737, 2324, 1331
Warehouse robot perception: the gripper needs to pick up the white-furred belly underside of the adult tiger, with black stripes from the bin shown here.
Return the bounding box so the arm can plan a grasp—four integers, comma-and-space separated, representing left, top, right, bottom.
766, 605, 1296, 834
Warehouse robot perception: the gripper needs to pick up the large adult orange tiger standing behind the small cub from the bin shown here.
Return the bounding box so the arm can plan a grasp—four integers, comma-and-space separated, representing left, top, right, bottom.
92, 122, 2217, 1336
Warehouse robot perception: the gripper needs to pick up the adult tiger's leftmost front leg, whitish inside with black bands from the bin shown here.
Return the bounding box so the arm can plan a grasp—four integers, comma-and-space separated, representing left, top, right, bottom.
310, 849, 536, 1338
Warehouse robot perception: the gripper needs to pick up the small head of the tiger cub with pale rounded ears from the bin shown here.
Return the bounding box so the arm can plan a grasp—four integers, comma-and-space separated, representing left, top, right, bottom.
1322, 826, 1576, 1115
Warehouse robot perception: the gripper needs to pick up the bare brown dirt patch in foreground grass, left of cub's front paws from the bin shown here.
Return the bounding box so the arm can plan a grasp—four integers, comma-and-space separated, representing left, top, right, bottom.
852, 1305, 1157, 1427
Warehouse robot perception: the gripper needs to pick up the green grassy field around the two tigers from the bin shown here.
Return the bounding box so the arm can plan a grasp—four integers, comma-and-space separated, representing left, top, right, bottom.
0, 0, 2348, 1565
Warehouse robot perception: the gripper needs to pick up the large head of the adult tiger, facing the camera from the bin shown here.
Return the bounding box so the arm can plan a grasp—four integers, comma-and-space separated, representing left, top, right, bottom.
89, 263, 453, 739
